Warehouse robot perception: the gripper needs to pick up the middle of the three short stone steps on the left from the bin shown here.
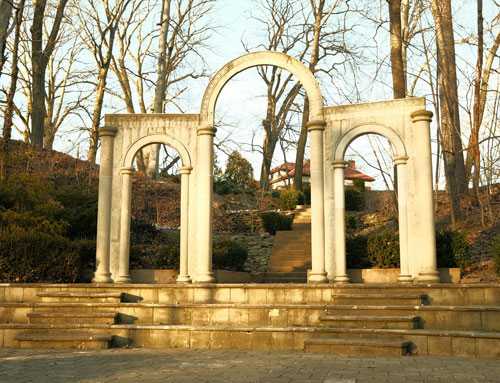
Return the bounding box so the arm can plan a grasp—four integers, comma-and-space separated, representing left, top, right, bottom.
27, 311, 118, 324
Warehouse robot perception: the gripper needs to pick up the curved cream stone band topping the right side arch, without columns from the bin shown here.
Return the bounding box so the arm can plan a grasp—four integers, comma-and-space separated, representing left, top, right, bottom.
334, 123, 407, 161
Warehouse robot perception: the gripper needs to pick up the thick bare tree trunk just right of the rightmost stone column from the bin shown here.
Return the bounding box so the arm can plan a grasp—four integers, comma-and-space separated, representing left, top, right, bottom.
431, 0, 467, 228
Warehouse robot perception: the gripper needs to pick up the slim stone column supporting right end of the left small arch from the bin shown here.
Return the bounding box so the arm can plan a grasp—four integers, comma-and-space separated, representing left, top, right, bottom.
177, 166, 193, 283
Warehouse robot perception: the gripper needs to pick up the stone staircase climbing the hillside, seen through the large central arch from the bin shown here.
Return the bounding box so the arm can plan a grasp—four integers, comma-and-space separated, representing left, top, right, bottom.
265, 206, 311, 283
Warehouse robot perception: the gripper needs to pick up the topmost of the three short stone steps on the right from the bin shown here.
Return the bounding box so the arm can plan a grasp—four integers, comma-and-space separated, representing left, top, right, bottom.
332, 293, 428, 305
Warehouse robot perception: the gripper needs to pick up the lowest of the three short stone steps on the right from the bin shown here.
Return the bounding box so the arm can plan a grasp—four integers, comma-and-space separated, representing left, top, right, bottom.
304, 338, 411, 356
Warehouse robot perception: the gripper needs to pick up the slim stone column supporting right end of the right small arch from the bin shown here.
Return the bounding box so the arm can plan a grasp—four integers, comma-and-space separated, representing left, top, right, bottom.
394, 156, 412, 283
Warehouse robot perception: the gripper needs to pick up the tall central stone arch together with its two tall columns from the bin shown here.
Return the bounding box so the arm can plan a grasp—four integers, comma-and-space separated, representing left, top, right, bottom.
196, 51, 328, 283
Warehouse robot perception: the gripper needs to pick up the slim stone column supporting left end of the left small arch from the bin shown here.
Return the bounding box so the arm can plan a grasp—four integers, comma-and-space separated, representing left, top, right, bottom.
115, 168, 135, 283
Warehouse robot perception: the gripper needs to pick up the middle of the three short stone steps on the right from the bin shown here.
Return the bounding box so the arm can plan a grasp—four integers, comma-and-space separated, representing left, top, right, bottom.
319, 315, 420, 329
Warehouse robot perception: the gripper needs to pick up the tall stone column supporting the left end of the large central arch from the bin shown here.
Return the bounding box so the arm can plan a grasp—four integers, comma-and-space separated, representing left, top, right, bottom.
194, 126, 217, 283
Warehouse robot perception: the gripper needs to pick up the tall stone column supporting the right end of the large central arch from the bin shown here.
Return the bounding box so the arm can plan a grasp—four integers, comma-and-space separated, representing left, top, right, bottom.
307, 120, 328, 283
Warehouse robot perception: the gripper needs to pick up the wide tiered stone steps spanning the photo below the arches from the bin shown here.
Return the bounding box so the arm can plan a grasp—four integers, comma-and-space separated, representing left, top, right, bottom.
0, 284, 500, 359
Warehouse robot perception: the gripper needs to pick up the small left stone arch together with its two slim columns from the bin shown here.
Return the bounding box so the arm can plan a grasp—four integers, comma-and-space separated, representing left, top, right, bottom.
115, 134, 192, 283
